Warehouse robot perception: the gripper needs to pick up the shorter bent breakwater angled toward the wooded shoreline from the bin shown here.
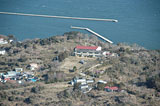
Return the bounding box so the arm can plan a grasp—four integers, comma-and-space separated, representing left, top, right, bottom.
71, 26, 113, 43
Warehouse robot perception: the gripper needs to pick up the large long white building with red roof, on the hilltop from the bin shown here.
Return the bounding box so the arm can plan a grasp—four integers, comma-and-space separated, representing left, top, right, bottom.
74, 46, 102, 57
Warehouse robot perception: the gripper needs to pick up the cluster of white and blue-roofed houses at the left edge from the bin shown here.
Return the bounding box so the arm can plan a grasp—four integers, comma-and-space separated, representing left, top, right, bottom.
0, 63, 38, 84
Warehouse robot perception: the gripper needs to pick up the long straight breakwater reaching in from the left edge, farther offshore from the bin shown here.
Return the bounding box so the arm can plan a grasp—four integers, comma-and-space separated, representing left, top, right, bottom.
0, 12, 118, 22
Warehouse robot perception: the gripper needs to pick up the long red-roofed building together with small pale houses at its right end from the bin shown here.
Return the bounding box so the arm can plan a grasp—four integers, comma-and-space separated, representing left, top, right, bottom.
74, 46, 118, 57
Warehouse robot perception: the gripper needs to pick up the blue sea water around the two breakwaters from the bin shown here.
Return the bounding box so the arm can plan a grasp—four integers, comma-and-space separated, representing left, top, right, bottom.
0, 0, 160, 49
